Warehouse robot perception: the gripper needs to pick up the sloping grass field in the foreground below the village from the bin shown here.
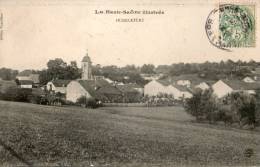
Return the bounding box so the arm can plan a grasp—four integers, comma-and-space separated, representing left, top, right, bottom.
0, 101, 260, 166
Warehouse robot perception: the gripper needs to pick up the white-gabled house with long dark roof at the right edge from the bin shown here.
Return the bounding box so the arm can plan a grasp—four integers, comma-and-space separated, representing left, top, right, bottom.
212, 80, 260, 98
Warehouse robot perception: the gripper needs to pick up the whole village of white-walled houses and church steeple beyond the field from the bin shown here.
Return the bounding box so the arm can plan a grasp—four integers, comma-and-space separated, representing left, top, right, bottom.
1, 54, 260, 105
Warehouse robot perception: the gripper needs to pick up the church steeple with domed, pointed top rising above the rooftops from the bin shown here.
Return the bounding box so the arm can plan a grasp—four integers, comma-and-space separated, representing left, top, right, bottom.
81, 53, 92, 80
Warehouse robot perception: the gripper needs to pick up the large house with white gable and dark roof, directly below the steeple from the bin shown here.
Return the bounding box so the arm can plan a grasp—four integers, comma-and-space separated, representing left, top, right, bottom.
66, 80, 122, 102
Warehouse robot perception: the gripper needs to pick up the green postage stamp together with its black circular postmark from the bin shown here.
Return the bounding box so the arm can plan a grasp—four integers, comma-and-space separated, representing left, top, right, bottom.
205, 4, 255, 50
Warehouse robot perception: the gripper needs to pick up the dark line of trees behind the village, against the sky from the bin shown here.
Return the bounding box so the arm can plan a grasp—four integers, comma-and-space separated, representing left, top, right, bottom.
0, 58, 260, 85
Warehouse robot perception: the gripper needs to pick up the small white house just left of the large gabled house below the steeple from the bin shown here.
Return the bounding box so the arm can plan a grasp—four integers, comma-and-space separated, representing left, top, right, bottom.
46, 79, 71, 94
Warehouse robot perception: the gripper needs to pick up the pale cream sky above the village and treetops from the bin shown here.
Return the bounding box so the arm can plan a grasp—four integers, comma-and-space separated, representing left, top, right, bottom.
0, 0, 260, 70
